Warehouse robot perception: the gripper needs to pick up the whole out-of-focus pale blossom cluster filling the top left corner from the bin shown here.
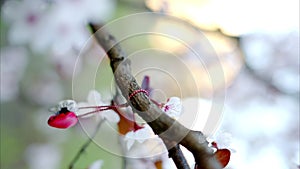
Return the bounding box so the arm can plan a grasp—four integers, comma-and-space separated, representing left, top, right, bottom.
1, 0, 114, 53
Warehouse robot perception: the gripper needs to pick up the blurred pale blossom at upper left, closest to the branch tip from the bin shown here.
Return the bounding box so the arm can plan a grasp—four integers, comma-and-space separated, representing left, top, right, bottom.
34, 2, 89, 54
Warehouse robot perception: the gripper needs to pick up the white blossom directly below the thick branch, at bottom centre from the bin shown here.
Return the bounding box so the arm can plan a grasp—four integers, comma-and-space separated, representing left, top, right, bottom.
124, 124, 171, 169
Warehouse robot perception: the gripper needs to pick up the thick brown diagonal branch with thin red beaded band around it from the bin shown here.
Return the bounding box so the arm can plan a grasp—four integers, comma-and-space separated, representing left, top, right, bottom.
91, 25, 222, 169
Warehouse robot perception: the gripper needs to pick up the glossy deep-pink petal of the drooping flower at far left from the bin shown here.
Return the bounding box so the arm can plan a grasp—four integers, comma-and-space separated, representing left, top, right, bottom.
48, 112, 78, 129
